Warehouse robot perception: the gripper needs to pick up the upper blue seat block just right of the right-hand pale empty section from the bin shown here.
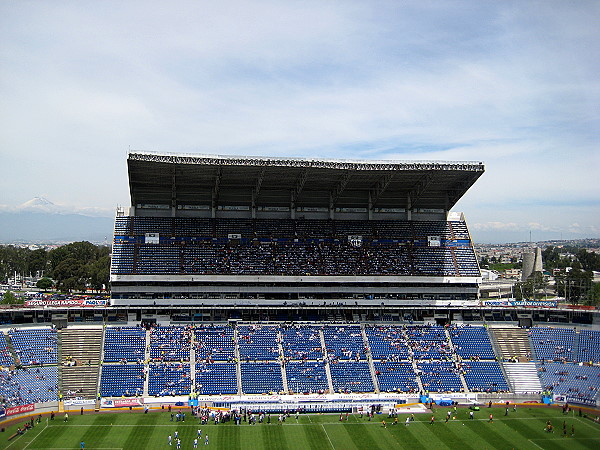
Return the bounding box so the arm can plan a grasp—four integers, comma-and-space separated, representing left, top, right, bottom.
529, 327, 577, 361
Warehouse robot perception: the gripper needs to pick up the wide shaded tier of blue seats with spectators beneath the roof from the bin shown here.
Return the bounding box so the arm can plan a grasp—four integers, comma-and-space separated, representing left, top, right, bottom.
112, 217, 480, 276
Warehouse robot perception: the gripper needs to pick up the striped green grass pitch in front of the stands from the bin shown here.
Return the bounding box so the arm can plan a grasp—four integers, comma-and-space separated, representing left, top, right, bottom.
0, 407, 600, 450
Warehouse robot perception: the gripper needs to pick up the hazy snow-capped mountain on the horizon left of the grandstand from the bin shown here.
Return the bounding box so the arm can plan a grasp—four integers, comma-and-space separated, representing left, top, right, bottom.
0, 210, 114, 243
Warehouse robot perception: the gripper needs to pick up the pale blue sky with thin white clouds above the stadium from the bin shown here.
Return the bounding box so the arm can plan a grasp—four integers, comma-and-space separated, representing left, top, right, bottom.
0, 0, 600, 246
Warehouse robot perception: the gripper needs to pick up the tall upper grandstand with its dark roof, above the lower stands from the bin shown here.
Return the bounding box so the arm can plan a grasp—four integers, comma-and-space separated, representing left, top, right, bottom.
111, 153, 484, 313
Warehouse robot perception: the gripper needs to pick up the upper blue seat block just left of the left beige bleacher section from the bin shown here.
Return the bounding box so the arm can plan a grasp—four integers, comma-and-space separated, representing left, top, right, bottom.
9, 328, 58, 366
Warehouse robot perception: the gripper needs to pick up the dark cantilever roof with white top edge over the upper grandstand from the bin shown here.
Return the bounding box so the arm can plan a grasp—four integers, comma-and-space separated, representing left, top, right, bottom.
127, 152, 485, 210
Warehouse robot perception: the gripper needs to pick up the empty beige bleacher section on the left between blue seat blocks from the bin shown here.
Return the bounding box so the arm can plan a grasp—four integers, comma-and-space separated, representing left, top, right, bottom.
59, 327, 103, 399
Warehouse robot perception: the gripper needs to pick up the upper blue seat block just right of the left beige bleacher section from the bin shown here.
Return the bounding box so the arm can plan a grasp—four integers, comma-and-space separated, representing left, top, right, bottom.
104, 327, 146, 362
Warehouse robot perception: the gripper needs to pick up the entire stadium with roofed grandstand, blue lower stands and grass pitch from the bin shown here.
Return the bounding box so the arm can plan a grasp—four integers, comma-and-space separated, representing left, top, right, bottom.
0, 152, 600, 449
